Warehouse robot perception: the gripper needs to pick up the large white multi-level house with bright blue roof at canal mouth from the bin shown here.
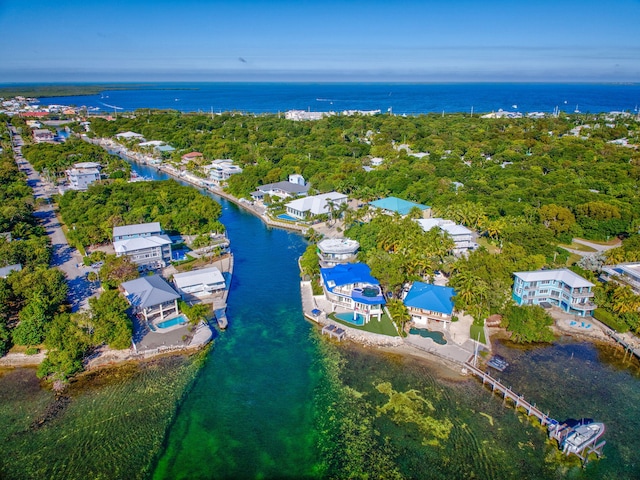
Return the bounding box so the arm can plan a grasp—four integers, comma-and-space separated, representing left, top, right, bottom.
320, 263, 386, 323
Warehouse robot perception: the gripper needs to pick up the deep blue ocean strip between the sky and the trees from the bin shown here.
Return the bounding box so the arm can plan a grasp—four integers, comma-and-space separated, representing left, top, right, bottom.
2, 82, 640, 115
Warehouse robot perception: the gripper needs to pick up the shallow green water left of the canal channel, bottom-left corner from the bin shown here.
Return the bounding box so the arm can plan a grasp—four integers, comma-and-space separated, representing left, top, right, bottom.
0, 353, 202, 479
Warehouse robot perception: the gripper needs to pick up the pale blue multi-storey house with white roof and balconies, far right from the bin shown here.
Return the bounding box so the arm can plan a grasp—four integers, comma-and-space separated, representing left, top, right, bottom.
512, 268, 596, 317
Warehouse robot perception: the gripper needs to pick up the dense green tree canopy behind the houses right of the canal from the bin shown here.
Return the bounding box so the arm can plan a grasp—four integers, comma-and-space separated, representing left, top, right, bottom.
86, 110, 640, 239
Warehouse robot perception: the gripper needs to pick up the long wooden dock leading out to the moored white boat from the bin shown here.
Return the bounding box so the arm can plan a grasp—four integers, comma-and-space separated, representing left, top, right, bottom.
465, 357, 607, 466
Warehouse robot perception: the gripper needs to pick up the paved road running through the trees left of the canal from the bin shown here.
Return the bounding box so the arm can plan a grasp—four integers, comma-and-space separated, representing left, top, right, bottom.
11, 127, 97, 312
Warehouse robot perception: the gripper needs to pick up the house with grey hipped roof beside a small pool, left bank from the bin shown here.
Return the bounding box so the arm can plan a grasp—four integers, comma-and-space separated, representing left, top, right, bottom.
120, 275, 180, 322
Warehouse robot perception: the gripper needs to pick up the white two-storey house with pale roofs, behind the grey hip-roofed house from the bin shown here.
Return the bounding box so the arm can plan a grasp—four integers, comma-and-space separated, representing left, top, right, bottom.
113, 222, 171, 269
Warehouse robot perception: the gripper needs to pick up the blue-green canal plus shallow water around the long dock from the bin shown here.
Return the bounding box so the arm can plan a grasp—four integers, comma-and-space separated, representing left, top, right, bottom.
125, 164, 640, 479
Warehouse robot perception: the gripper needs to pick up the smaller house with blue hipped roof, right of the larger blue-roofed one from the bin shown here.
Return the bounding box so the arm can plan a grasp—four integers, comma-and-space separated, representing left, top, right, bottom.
403, 282, 456, 328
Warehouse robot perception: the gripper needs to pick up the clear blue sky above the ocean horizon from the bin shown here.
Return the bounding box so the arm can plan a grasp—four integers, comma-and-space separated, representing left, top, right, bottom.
0, 0, 640, 83
